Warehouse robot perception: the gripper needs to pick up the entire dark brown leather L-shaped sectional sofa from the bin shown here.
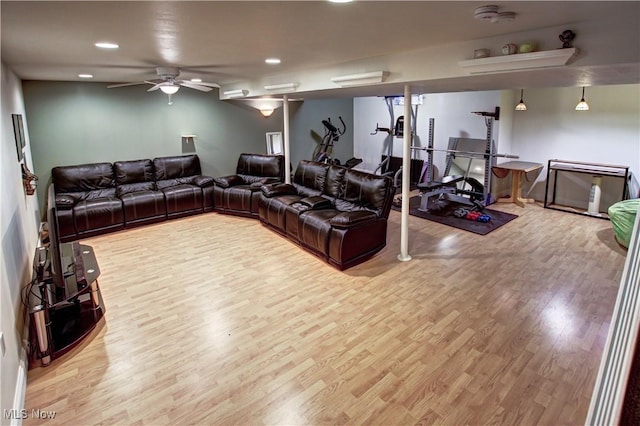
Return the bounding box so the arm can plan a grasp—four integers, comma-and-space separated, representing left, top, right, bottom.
49, 154, 395, 270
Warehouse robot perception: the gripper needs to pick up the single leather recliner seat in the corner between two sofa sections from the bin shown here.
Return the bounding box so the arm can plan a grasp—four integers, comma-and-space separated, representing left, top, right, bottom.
213, 153, 284, 218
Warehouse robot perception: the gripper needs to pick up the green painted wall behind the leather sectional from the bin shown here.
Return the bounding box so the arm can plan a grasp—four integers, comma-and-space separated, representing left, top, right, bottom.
22, 81, 353, 211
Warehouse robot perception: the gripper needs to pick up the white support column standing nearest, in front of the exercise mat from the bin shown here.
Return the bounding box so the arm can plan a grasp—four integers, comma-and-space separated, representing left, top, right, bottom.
398, 84, 413, 262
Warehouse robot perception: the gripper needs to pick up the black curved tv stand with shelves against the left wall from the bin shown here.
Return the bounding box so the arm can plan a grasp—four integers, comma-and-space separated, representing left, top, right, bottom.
29, 243, 105, 367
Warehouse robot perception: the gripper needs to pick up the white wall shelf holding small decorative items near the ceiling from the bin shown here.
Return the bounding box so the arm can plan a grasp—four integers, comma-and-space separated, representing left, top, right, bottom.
458, 47, 578, 74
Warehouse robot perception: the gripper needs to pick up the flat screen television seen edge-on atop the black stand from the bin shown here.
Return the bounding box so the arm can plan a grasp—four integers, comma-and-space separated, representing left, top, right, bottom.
47, 187, 75, 300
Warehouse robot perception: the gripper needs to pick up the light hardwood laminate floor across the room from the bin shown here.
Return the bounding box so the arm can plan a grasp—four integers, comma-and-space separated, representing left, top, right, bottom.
24, 204, 625, 425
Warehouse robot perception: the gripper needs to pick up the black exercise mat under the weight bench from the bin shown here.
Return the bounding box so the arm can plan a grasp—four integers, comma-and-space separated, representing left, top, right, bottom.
391, 196, 518, 235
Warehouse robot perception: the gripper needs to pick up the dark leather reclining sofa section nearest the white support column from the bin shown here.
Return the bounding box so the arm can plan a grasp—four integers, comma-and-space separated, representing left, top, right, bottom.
259, 161, 395, 270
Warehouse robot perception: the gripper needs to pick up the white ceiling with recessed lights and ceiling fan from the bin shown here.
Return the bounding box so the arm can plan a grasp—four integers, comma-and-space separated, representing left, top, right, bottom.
0, 0, 640, 97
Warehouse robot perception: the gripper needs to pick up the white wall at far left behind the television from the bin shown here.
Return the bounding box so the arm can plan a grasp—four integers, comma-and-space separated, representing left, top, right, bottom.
0, 63, 40, 425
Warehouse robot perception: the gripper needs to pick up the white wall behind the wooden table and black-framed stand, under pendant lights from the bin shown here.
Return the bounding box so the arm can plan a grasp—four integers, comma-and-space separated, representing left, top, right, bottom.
503, 85, 640, 207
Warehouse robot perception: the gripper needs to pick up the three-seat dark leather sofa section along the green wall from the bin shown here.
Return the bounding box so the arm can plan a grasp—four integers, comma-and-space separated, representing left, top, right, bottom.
49, 155, 213, 242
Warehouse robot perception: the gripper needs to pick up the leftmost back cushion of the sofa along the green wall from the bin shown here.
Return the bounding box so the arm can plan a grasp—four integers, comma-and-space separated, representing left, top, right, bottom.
51, 163, 116, 199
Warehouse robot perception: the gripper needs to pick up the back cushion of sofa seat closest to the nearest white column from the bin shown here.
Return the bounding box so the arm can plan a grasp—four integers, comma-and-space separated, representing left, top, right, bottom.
336, 169, 394, 218
